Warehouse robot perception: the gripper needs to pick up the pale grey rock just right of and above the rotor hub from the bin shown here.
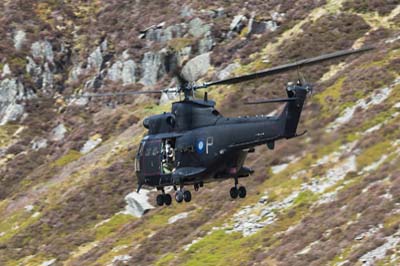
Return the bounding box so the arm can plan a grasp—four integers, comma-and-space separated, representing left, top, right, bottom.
182, 53, 210, 81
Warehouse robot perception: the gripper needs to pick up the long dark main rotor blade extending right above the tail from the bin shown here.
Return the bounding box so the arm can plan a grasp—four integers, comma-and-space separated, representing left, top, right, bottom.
202, 46, 375, 89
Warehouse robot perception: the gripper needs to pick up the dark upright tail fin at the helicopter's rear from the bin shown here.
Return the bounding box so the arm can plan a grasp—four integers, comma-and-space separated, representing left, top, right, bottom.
280, 84, 311, 139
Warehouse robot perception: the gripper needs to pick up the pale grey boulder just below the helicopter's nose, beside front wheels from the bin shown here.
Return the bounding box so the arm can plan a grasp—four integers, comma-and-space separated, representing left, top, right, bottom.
123, 189, 154, 217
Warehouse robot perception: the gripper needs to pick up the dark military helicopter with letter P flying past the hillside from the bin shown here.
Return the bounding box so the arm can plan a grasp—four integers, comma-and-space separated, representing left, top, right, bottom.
99, 47, 368, 206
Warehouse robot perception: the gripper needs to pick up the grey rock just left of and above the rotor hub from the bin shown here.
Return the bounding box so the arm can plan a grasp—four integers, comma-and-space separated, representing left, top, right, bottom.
139, 52, 165, 86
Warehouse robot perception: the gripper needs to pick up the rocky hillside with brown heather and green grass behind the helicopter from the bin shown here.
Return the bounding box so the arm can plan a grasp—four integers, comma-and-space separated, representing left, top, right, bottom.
0, 0, 400, 265
